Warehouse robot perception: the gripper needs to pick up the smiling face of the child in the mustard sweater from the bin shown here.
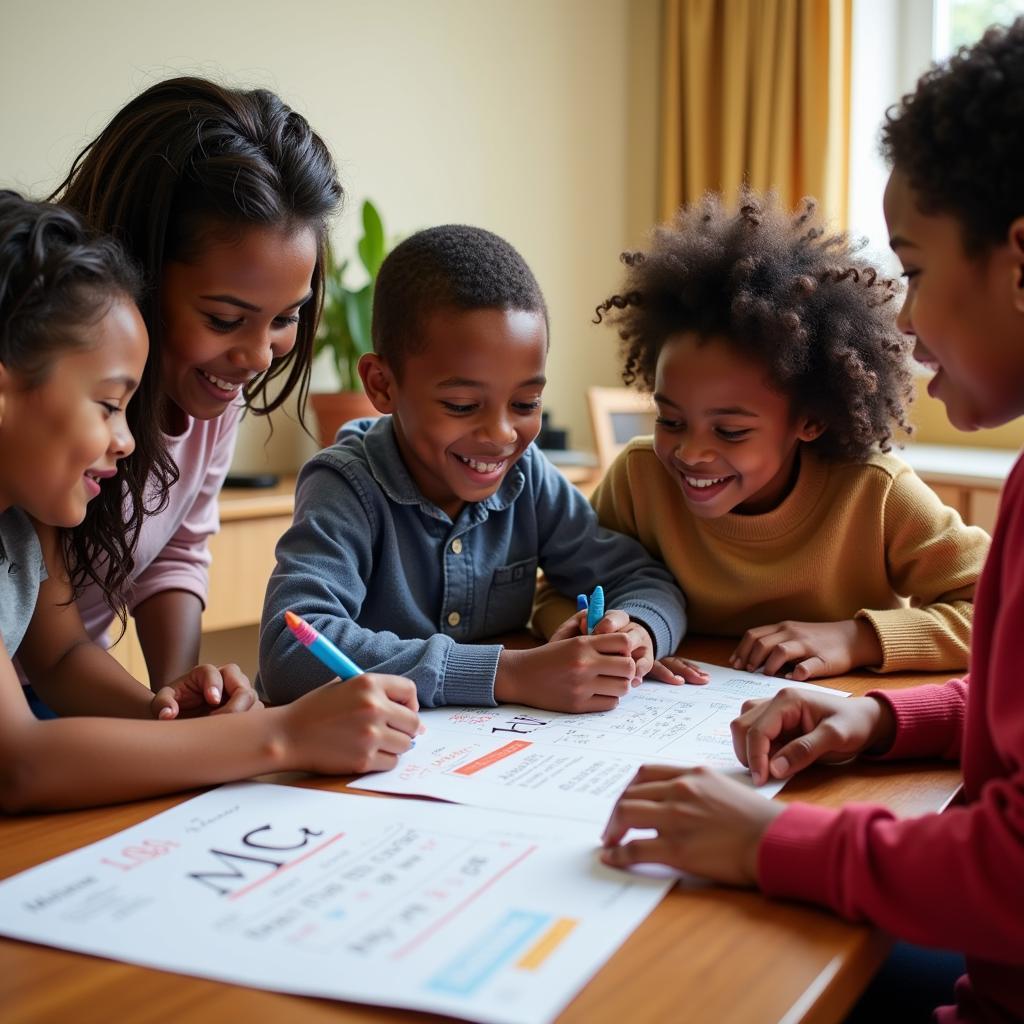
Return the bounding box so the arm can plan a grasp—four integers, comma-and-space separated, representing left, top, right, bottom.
654, 332, 821, 519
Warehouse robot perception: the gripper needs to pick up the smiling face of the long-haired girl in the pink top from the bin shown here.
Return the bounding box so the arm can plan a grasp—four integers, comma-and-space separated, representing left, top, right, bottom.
161, 227, 317, 431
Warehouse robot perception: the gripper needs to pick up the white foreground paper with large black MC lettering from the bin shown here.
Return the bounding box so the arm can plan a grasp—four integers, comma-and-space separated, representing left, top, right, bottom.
0, 782, 672, 1024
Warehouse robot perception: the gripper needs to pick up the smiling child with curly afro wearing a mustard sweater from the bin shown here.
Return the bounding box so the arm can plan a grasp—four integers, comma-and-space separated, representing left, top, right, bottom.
536, 193, 988, 682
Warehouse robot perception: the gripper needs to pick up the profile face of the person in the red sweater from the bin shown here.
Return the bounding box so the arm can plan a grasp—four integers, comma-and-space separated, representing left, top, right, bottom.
885, 170, 1024, 430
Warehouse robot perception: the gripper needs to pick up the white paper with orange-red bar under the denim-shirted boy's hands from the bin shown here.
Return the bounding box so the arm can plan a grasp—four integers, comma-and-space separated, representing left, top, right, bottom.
352, 662, 849, 825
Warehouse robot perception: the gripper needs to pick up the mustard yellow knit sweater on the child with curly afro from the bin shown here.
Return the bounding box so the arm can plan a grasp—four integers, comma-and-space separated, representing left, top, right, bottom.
534, 437, 989, 672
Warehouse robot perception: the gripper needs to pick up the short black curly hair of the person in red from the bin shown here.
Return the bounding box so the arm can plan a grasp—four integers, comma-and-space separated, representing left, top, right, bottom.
882, 17, 1024, 256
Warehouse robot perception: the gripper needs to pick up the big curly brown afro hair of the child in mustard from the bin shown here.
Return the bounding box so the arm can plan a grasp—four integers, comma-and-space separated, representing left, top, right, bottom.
595, 191, 912, 459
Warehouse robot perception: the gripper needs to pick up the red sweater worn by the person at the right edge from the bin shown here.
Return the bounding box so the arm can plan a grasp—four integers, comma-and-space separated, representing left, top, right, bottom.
758, 460, 1024, 962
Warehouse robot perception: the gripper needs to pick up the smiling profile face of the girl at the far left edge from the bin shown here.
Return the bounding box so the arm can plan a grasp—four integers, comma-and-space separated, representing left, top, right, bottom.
0, 299, 150, 527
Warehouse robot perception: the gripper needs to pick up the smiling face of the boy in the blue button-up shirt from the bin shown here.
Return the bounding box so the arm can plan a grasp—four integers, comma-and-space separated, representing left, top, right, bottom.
359, 308, 548, 519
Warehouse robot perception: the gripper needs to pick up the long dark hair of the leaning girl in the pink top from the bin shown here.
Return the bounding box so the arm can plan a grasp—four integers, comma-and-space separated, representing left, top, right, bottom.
50, 78, 343, 513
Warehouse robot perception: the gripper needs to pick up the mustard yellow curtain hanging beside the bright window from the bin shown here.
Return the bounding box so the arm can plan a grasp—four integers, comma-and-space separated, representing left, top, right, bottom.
659, 0, 852, 226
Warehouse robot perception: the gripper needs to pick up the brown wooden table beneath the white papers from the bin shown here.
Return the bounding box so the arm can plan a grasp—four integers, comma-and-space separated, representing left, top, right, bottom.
0, 640, 959, 1024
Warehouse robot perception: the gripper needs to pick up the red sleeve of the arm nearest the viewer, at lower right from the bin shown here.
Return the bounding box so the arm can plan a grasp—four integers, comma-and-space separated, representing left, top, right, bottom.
758, 777, 1024, 963
